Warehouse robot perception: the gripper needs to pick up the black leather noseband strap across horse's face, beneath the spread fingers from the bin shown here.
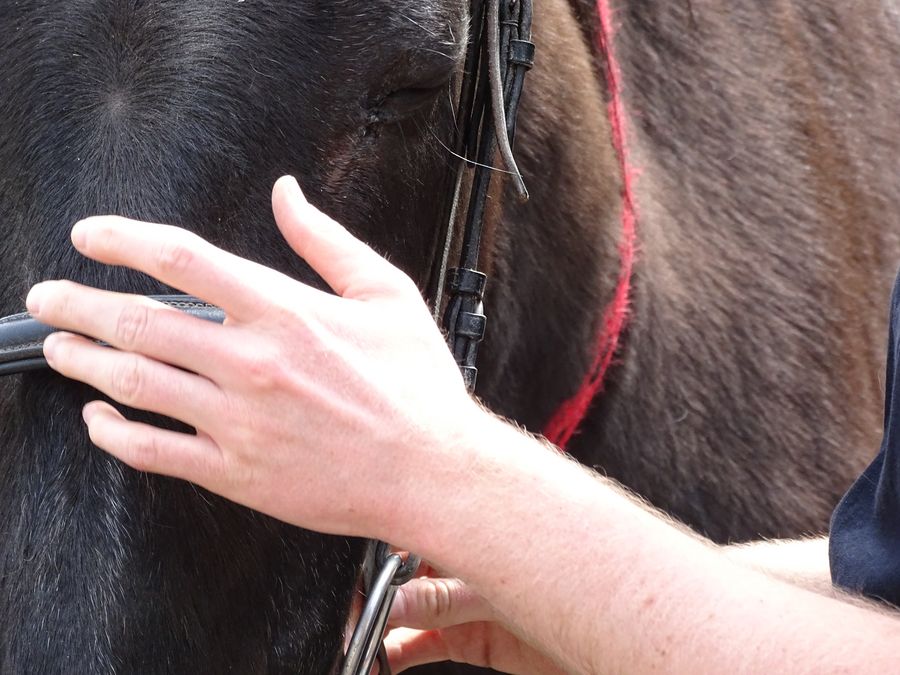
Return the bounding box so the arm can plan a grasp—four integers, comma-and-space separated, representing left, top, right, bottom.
0, 295, 225, 376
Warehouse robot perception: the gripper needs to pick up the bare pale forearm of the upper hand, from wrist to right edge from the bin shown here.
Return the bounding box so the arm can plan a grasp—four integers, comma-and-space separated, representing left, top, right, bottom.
397, 414, 900, 673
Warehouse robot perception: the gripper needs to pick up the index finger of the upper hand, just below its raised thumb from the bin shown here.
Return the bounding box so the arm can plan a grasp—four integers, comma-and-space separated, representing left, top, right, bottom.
72, 216, 290, 321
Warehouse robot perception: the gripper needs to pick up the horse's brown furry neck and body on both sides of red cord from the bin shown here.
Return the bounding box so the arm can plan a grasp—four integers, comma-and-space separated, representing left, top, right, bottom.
481, 0, 900, 540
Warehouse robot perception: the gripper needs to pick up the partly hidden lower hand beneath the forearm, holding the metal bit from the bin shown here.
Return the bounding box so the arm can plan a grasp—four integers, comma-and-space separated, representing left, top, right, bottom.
385, 568, 565, 675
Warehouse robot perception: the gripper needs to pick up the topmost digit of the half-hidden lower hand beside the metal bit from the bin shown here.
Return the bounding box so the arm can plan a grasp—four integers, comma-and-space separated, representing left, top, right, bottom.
389, 577, 495, 630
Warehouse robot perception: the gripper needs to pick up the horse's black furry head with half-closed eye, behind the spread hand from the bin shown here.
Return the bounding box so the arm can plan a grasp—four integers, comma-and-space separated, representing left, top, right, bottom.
0, 0, 492, 673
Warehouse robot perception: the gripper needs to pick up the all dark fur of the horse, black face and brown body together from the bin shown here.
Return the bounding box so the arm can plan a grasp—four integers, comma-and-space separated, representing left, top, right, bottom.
0, 0, 900, 675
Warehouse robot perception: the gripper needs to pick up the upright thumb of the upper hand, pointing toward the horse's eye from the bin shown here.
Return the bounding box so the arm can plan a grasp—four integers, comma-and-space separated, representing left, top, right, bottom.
272, 176, 418, 300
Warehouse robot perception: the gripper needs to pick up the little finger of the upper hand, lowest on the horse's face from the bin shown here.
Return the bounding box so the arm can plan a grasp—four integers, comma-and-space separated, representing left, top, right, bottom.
84, 402, 221, 486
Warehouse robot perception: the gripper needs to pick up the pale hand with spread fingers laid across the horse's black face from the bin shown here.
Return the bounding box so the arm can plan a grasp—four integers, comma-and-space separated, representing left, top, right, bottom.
27, 178, 485, 537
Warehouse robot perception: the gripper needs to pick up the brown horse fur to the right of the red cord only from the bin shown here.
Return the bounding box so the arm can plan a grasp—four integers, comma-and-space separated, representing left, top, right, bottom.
560, 0, 900, 539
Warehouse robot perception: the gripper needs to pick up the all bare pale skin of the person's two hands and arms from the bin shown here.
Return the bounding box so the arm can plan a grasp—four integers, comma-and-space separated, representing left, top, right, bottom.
27, 178, 900, 674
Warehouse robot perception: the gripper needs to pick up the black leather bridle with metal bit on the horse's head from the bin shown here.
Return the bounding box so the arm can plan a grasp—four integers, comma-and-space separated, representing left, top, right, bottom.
0, 0, 535, 675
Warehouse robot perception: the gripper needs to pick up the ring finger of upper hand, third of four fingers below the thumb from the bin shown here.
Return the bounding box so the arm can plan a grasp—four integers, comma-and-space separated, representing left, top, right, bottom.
44, 333, 222, 428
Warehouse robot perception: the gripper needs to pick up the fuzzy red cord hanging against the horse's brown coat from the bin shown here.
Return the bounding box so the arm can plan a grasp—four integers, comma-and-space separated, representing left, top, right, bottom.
544, 0, 637, 449
